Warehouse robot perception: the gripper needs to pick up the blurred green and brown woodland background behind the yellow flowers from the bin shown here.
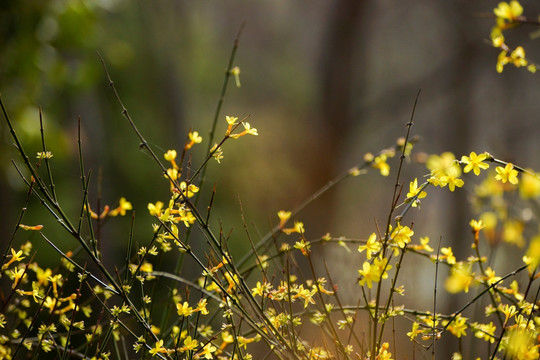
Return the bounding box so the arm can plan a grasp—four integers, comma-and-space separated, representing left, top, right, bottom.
0, 0, 540, 358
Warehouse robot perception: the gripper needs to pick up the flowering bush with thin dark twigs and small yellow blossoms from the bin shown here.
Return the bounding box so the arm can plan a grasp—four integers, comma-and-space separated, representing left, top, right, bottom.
0, 1, 540, 360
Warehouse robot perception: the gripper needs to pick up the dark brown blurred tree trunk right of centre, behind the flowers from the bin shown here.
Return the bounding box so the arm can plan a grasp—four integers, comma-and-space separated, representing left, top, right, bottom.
307, 0, 365, 239
